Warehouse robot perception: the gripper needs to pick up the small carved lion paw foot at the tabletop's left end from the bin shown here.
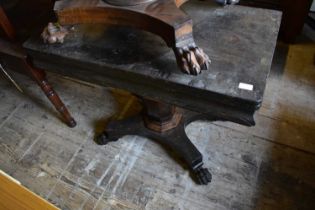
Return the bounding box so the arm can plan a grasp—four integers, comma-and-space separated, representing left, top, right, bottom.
41, 23, 69, 44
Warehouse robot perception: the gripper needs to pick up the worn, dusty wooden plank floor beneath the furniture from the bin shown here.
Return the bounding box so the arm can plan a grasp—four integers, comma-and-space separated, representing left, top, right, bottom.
0, 27, 315, 210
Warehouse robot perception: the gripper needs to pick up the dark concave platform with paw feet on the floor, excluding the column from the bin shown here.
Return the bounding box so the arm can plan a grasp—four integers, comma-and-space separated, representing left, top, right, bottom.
95, 107, 212, 185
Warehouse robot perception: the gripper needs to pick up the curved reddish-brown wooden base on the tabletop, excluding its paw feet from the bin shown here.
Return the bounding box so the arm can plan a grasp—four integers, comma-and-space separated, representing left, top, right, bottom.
55, 0, 192, 47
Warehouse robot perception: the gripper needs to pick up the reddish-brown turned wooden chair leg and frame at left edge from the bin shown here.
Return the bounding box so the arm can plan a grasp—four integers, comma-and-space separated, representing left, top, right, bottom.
0, 6, 76, 127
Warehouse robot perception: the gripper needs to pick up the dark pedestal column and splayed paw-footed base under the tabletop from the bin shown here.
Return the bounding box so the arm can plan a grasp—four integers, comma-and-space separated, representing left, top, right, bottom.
95, 99, 212, 185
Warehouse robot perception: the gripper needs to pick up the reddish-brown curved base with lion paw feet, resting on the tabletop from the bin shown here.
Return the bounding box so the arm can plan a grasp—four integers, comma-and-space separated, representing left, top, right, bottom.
43, 0, 211, 75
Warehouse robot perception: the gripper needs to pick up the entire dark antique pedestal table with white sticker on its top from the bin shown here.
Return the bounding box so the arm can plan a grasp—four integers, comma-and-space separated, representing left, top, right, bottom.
24, 1, 281, 184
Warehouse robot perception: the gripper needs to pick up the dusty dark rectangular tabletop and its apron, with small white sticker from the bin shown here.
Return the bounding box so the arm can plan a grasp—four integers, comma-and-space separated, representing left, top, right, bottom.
29, 2, 280, 125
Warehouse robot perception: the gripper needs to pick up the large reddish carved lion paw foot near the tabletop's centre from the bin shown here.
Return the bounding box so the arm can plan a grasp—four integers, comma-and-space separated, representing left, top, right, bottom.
174, 45, 211, 75
